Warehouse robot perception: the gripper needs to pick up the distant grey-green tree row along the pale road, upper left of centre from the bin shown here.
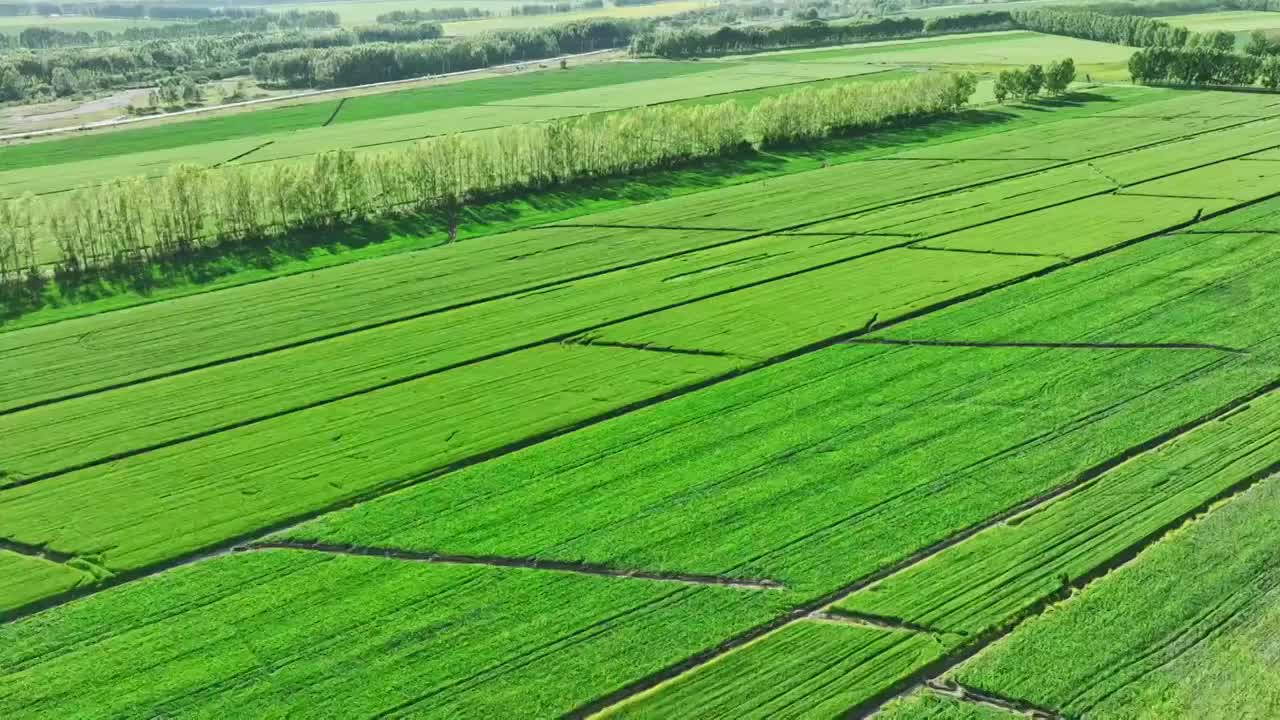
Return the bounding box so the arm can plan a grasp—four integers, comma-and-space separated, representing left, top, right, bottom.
251, 18, 641, 87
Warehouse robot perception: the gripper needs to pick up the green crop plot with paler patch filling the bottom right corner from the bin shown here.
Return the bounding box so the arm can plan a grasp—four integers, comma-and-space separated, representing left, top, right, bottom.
955, 471, 1280, 717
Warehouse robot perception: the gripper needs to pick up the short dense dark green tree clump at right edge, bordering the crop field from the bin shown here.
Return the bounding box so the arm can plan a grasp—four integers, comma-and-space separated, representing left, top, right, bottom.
1129, 47, 1280, 90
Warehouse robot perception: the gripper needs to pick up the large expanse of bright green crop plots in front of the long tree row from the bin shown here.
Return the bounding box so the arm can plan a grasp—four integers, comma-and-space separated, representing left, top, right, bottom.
0, 78, 1280, 719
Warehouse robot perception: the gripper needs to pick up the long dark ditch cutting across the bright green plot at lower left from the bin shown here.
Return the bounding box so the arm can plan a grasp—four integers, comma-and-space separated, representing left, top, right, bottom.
233, 539, 786, 591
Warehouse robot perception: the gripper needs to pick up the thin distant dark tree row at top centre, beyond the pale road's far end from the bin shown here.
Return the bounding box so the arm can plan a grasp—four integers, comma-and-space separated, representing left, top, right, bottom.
631, 12, 1011, 58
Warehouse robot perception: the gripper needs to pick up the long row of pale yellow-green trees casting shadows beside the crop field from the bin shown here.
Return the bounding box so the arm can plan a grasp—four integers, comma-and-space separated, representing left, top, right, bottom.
0, 74, 975, 278
